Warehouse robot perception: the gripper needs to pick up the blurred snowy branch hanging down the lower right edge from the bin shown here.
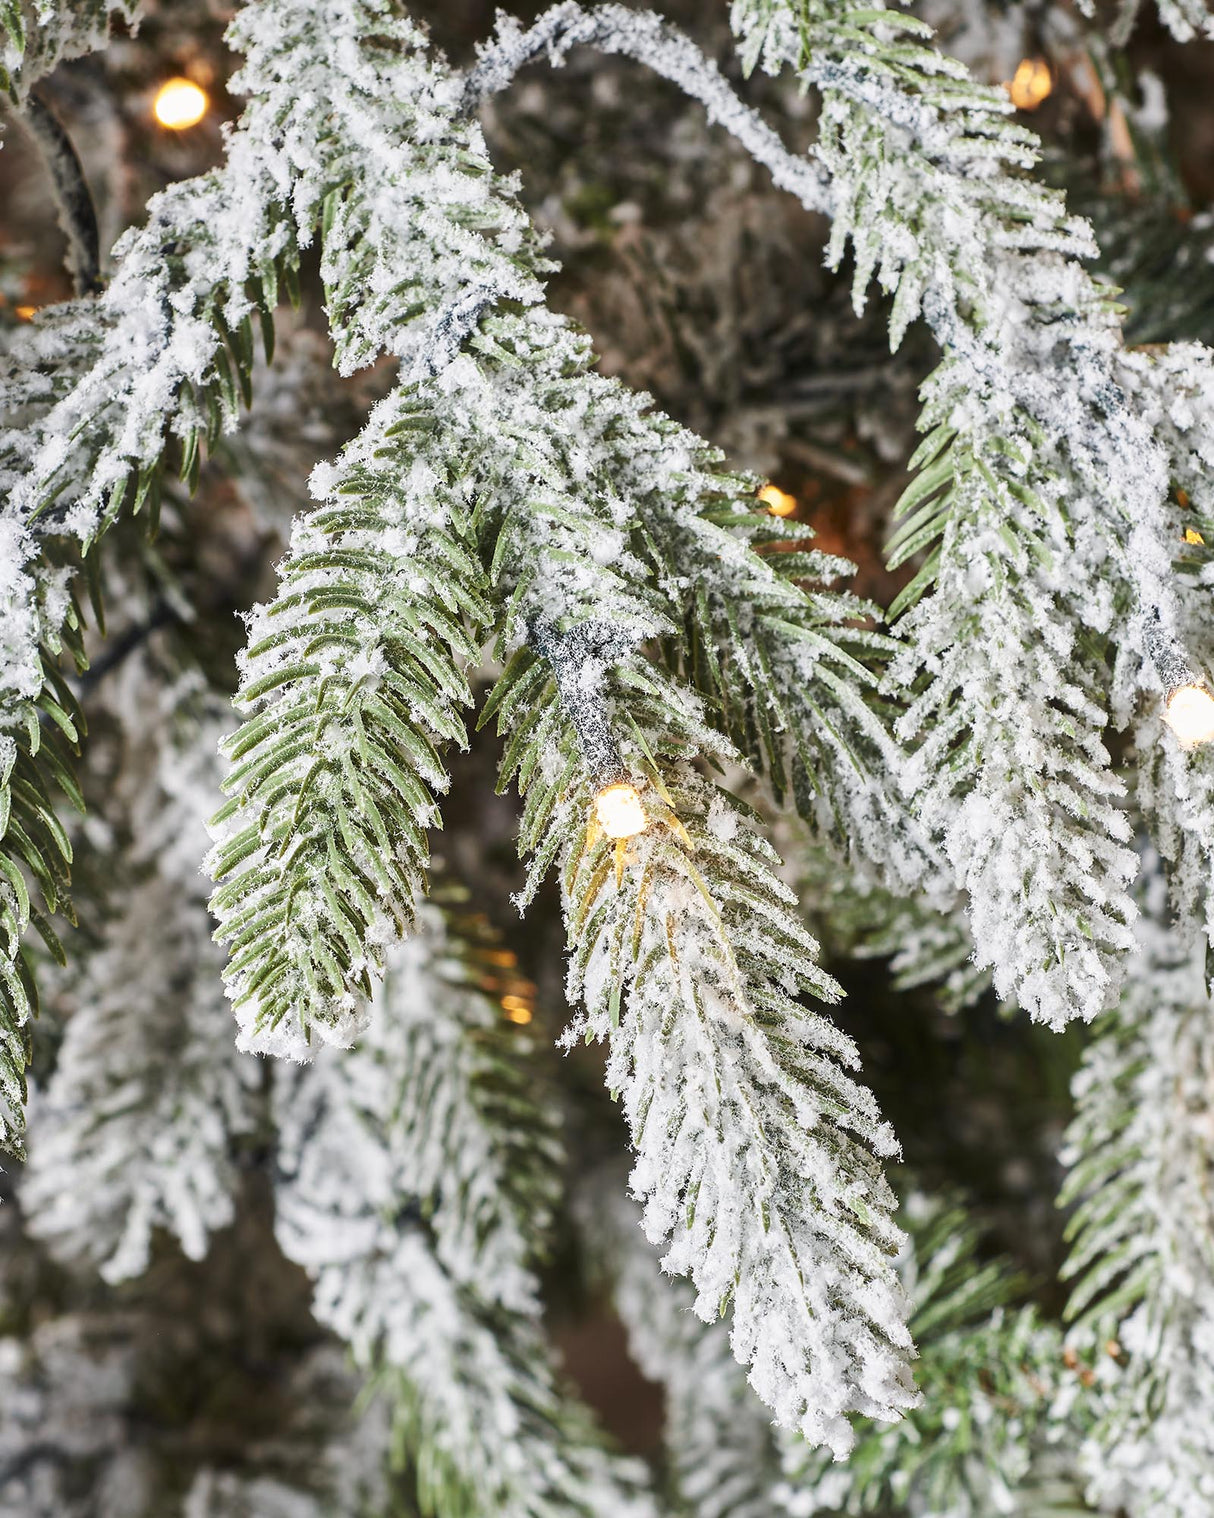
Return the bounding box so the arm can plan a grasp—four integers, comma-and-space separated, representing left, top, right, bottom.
1061, 859, 1214, 1518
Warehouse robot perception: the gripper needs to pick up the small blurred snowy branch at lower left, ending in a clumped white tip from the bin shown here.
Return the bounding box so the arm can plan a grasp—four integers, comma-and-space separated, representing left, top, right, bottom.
21, 683, 256, 1281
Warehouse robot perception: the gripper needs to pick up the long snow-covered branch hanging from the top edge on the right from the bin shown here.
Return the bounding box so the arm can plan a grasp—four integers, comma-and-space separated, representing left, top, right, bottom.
733, 0, 1175, 1025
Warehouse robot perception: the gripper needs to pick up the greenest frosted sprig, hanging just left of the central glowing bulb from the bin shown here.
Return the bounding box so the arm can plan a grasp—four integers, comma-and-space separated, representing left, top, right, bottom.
208, 392, 490, 1058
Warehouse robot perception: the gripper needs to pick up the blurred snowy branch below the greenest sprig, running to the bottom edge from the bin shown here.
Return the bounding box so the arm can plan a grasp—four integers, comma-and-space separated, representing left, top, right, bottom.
276, 908, 654, 1518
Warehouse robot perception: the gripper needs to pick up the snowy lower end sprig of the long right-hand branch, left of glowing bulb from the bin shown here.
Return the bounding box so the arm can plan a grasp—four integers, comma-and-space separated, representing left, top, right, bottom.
891, 440, 1137, 1026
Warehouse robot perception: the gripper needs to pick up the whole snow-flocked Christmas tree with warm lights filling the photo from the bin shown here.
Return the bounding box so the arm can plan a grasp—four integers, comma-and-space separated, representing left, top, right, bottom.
0, 0, 1214, 1518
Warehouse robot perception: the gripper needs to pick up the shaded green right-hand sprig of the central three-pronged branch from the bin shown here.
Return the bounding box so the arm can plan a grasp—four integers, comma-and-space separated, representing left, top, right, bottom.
643, 485, 947, 899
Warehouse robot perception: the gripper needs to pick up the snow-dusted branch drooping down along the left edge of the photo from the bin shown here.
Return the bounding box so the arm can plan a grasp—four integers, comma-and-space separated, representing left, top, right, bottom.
0, 207, 279, 1099
